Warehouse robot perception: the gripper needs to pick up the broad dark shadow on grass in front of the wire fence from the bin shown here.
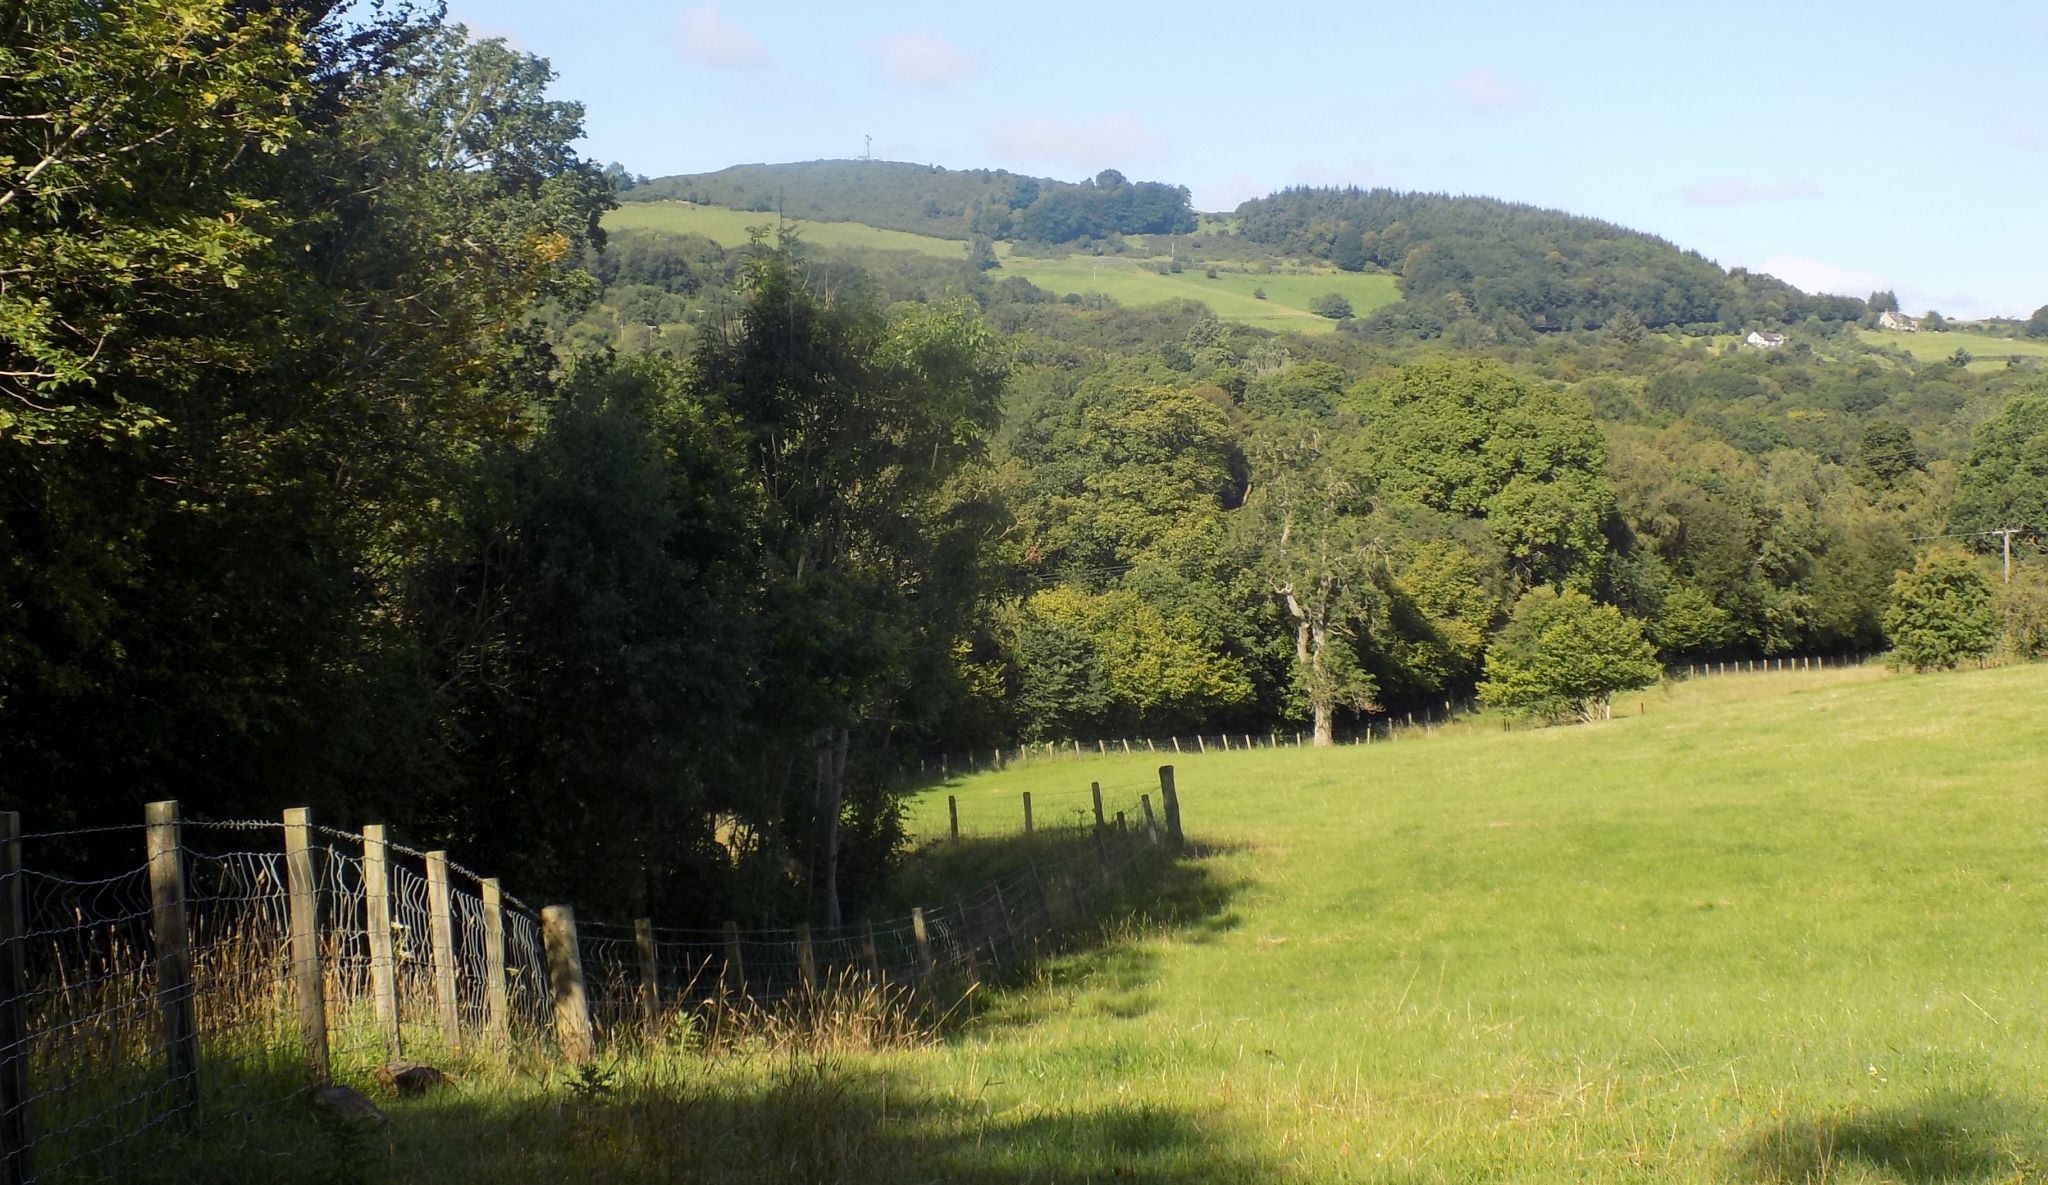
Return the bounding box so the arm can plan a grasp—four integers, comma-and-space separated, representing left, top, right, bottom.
131, 1058, 1284, 1185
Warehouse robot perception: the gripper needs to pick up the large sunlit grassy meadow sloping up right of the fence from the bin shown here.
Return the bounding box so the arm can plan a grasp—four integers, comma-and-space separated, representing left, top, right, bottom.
163, 665, 2048, 1185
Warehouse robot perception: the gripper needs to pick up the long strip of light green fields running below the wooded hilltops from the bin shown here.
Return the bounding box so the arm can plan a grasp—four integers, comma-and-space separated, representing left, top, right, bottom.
604, 203, 1401, 334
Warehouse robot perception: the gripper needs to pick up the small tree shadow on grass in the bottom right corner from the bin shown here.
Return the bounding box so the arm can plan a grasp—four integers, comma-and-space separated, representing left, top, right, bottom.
1741, 1091, 2042, 1185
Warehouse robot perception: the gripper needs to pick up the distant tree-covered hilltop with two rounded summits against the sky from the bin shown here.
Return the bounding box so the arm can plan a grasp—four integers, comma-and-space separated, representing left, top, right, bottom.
621, 160, 1866, 338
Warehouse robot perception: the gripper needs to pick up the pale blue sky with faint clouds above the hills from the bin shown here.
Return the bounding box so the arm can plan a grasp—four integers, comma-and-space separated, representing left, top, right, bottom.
449, 0, 2048, 315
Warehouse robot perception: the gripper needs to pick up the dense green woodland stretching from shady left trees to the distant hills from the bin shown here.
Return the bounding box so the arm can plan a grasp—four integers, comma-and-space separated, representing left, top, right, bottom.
0, 0, 2048, 937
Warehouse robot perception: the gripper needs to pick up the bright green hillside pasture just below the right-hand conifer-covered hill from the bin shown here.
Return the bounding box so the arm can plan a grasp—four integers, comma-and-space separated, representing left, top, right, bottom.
1001, 256, 1401, 334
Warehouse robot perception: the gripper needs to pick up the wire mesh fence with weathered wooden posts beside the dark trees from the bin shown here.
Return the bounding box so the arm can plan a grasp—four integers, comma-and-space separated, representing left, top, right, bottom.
0, 772, 1178, 1185
